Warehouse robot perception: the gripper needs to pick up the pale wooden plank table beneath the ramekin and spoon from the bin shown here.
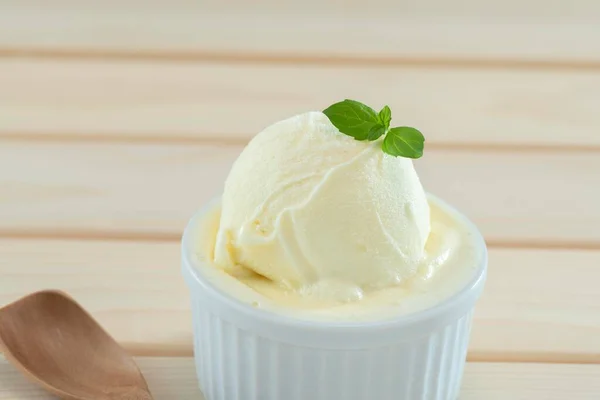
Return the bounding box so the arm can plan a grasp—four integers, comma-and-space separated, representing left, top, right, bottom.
0, 0, 600, 400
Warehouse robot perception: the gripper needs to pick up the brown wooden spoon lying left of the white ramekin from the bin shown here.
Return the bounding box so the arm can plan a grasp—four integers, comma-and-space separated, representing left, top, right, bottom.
0, 291, 152, 400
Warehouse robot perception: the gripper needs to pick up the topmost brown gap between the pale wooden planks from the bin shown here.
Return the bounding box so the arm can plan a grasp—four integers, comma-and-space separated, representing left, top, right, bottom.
0, 47, 600, 71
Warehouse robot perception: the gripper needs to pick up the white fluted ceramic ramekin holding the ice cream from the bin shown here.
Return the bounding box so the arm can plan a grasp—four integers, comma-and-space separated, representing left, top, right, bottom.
182, 198, 487, 400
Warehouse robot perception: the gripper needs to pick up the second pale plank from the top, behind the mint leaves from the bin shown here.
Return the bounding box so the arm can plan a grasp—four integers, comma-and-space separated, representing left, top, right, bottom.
0, 58, 600, 151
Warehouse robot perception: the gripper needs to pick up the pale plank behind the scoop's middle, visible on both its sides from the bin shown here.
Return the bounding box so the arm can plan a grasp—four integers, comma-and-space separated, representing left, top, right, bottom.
0, 141, 600, 247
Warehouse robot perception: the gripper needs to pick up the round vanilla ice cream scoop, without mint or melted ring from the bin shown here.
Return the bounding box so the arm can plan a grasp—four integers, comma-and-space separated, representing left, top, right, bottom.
214, 112, 431, 301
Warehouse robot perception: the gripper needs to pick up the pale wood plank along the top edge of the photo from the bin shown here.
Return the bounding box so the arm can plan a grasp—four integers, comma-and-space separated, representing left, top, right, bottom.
0, 0, 600, 62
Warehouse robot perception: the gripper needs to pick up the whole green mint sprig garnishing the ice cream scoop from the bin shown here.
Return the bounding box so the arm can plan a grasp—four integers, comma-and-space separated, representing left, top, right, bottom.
323, 99, 425, 158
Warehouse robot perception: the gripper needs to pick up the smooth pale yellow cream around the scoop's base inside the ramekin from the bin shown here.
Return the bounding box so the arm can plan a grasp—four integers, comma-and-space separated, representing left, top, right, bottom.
192, 197, 484, 321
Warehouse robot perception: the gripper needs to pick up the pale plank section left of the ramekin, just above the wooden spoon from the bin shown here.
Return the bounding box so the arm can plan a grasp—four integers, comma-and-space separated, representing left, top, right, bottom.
0, 239, 192, 355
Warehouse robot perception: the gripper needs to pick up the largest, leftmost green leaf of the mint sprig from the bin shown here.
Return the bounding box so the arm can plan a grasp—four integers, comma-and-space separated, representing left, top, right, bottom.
323, 99, 381, 140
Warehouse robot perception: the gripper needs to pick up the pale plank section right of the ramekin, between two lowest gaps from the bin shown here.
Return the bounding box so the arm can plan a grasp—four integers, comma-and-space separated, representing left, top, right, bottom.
469, 248, 600, 363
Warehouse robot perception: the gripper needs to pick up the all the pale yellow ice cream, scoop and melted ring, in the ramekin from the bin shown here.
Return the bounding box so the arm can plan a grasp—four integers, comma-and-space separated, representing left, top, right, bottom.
192, 112, 481, 319
